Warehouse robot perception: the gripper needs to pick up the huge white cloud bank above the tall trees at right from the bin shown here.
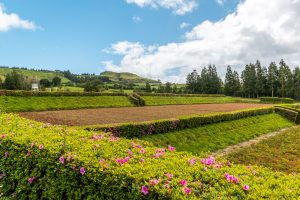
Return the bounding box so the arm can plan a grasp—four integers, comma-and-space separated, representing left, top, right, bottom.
106, 0, 300, 82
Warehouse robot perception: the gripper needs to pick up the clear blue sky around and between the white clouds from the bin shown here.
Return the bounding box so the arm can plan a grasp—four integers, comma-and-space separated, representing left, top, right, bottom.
0, 0, 239, 75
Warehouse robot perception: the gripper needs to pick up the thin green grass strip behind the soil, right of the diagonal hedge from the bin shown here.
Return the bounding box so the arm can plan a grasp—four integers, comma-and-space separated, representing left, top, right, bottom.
143, 96, 259, 106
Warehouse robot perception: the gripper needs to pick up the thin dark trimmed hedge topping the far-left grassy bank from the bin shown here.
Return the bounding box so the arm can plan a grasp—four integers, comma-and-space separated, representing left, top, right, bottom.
0, 90, 127, 97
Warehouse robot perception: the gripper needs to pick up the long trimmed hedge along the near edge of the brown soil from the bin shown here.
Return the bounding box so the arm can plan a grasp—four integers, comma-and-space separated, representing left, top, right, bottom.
84, 107, 274, 138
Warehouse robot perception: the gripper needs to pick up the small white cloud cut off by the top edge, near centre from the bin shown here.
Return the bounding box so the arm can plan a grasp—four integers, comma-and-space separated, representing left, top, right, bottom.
126, 0, 197, 15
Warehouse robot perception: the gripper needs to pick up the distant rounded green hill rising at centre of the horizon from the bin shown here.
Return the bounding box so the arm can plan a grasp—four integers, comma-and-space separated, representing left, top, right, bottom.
100, 71, 158, 83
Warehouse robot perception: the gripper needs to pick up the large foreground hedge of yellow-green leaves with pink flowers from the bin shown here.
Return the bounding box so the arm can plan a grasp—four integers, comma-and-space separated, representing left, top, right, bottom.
0, 114, 300, 199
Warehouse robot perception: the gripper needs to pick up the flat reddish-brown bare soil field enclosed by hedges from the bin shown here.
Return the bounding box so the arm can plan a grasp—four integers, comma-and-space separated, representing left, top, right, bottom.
19, 103, 266, 126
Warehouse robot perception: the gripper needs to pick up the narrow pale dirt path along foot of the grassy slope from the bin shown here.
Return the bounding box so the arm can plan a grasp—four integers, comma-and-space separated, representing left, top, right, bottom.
212, 126, 299, 157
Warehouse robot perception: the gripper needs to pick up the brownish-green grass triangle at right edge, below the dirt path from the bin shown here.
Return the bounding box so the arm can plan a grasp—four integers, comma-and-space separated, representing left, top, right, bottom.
228, 127, 300, 173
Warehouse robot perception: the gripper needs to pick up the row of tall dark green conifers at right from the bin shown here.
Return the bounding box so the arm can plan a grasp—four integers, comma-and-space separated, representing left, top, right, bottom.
186, 60, 300, 99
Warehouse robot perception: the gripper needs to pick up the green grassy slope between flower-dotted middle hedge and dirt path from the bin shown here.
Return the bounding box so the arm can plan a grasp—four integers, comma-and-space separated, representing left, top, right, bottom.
143, 113, 293, 153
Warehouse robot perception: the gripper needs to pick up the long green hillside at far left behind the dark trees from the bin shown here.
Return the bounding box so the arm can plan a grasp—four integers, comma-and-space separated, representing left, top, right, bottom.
0, 67, 70, 83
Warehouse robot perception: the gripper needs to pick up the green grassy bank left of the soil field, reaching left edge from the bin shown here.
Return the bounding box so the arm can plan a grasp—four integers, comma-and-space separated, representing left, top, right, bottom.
0, 96, 132, 112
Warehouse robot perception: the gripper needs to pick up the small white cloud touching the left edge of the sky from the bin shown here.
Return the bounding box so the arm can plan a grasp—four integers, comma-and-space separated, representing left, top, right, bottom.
0, 3, 37, 32
